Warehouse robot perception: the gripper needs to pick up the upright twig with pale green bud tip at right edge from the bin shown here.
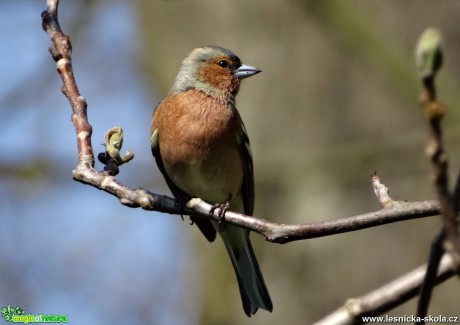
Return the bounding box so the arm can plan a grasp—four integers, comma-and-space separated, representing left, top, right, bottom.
416, 28, 460, 324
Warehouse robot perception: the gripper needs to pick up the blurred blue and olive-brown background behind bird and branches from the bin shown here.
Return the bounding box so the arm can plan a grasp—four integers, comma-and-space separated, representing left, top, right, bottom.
0, 0, 460, 324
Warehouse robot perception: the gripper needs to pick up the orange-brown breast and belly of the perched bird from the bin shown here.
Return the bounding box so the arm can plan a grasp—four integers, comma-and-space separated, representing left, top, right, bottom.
152, 90, 243, 203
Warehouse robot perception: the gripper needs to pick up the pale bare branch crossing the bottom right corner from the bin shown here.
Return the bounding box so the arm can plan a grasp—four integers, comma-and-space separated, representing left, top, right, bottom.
315, 255, 455, 325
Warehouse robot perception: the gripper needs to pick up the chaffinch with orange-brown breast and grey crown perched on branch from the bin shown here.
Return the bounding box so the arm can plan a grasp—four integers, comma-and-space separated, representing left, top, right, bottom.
150, 46, 273, 317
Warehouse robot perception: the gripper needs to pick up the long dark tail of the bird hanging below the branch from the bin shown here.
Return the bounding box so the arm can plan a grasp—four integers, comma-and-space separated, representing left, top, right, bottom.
220, 225, 273, 317
